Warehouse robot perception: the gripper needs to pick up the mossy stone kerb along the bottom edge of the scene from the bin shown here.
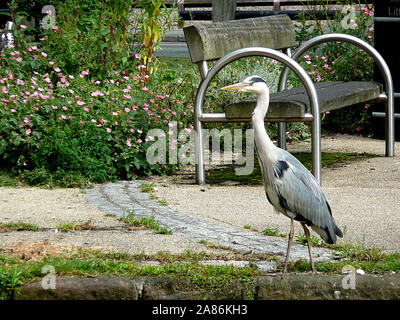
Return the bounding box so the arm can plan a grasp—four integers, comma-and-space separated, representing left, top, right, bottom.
13, 274, 400, 300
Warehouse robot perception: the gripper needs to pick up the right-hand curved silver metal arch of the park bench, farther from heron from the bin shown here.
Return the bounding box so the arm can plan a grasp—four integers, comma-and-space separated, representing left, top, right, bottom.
278, 33, 394, 157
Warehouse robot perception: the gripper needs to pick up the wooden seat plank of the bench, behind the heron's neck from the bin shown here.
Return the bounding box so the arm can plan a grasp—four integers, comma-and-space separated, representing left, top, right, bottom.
225, 81, 382, 120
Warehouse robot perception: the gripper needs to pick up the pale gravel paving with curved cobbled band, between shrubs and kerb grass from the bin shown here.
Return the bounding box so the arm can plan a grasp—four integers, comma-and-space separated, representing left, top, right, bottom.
0, 136, 400, 266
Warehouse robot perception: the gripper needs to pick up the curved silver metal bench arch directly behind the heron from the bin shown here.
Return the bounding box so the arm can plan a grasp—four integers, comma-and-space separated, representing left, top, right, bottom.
195, 47, 321, 184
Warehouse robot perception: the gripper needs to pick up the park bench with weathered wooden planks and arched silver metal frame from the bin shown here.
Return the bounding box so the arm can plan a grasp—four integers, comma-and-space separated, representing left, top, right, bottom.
184, 15, 394, 184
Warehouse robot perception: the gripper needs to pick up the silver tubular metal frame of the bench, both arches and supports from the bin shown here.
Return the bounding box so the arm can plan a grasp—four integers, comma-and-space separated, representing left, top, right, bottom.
187, 16, 394, 184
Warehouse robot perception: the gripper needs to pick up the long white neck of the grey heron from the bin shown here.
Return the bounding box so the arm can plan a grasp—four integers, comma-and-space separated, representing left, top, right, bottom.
251, 90, 275, 156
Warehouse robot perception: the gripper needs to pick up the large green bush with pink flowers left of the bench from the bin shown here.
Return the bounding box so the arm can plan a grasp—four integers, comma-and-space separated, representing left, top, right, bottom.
0, 35, 193, 186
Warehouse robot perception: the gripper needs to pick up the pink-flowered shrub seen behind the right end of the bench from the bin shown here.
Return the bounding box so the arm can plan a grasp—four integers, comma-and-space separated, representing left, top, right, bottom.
294, 5, 374, 134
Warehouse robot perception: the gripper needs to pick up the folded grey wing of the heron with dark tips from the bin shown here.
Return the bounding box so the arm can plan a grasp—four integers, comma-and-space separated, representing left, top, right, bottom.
275, 149, 337, 242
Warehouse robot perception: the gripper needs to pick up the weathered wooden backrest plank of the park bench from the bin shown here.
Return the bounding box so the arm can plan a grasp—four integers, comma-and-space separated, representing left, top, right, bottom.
183, 15, 295, 63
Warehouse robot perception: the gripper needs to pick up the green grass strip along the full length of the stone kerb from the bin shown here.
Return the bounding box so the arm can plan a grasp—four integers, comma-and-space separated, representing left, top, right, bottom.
0, 242, 400, 299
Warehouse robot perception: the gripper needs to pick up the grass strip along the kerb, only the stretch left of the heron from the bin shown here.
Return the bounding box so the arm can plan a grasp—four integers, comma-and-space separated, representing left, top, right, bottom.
0, 249, 259, 299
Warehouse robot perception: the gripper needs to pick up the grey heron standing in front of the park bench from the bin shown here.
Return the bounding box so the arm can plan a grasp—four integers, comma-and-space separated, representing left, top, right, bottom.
221, 76, 343, 274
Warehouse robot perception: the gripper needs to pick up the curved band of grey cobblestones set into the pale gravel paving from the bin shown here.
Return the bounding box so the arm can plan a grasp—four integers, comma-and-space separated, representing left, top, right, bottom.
85, 180, 331, 261
